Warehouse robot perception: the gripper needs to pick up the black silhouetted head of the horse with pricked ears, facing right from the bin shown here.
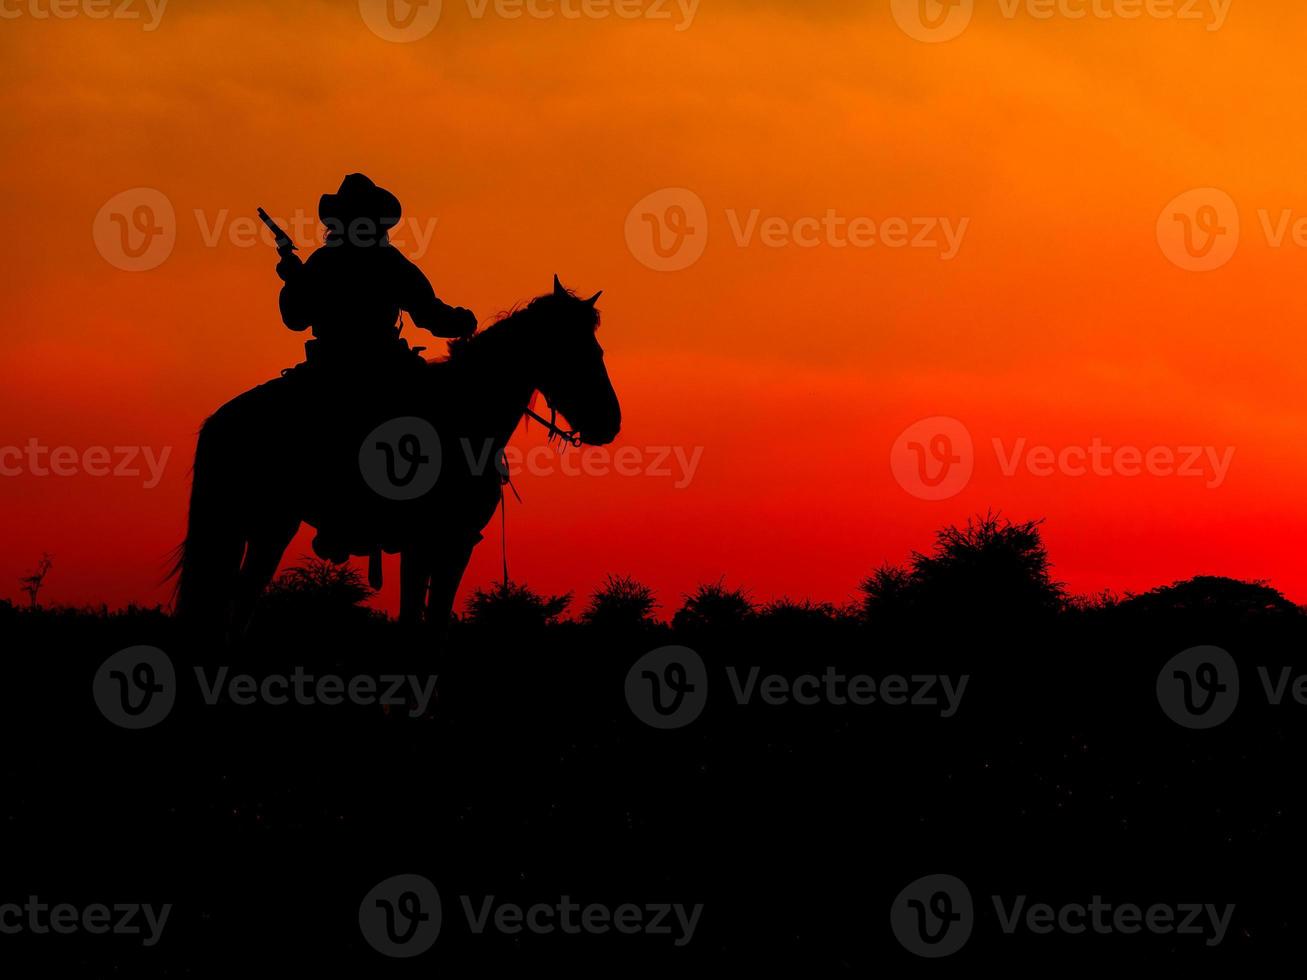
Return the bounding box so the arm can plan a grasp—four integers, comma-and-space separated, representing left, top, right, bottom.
532, 276, 622, 446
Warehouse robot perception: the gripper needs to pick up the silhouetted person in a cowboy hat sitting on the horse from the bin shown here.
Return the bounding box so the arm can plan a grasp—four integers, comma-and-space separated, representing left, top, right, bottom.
277, 174, 477, 365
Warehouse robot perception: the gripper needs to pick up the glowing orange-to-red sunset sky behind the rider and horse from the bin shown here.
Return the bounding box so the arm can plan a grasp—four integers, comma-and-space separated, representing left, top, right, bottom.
0, 0, 1307, 608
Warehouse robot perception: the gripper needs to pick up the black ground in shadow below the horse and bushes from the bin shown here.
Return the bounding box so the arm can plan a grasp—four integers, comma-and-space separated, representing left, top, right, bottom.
0, 582, 1307, 976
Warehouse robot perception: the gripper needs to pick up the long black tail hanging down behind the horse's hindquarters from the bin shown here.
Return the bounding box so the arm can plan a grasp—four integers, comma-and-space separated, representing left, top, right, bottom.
173, 410, 246, 629
